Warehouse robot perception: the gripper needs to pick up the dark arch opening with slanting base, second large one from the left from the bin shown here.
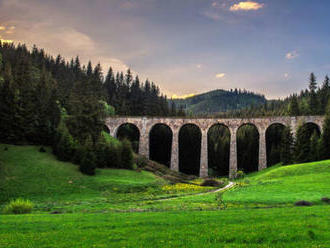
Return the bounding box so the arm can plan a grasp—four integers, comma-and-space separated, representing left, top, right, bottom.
149, 124, 173, 167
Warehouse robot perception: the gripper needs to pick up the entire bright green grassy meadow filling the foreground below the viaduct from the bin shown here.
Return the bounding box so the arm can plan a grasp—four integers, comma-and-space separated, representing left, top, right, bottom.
0, 145, 330, 248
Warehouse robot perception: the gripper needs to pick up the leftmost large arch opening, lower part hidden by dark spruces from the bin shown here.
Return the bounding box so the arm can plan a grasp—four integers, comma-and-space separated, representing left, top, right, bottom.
116, 123, 140, 153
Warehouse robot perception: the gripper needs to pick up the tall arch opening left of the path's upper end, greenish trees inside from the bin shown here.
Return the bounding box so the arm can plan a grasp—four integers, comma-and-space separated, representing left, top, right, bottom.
207, 124, 230, 176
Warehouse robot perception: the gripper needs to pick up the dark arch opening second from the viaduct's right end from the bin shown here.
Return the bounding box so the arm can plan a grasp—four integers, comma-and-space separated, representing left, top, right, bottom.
266, 123, 285, 167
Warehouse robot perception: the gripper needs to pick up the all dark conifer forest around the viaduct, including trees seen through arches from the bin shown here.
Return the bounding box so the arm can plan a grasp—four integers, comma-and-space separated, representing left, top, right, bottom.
0, 43, 330, 176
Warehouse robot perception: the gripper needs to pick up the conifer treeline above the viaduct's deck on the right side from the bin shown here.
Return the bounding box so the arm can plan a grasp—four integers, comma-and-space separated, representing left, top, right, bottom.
218, 73, 330, 117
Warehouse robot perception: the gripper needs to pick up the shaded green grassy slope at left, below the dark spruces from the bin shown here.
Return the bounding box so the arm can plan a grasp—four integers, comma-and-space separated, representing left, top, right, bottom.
0, 145, 162, 203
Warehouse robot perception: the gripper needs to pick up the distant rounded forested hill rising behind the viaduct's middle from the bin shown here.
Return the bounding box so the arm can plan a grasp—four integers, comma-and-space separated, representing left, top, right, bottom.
173, 89, 267, 115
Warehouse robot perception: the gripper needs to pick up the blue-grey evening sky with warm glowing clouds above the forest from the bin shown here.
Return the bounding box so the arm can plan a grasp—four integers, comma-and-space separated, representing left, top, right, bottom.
0, 0, 330, 99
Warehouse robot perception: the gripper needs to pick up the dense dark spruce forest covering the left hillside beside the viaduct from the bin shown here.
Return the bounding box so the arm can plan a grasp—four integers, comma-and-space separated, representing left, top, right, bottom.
0, 43, 177, 174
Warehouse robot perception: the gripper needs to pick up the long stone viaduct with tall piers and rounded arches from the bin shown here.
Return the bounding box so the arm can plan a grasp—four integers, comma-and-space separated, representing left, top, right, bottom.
105, 116, 324, 177
